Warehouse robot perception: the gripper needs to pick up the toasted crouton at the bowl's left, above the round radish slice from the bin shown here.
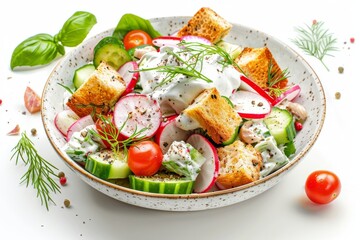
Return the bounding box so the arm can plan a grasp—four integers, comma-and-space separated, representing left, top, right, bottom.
66, 62, 126, 117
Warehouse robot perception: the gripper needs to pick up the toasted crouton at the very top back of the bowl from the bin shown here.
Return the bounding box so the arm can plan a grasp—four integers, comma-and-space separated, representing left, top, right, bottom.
177, 7, 232, 43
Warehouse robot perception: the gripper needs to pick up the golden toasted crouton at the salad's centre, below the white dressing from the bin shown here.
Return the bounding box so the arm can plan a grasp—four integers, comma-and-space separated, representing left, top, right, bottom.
181, 88, 242, 144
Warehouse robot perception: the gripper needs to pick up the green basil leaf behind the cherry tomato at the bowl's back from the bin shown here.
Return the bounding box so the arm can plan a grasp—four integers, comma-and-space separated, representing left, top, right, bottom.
113, 13, 161, 39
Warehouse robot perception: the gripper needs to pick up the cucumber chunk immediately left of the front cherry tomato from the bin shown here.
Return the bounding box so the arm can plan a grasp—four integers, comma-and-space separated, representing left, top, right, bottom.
85, 149, 130, 180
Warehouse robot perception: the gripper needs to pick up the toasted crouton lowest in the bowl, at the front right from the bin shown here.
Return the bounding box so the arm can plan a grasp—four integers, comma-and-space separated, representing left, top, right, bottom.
216, 140, 262, 189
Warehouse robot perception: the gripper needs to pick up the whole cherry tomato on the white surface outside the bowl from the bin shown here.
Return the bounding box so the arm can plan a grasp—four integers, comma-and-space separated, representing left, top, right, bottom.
305, 170, 341, 204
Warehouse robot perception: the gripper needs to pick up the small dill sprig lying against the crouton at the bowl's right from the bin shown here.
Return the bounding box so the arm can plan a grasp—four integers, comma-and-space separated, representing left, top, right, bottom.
267, 60, 290, 97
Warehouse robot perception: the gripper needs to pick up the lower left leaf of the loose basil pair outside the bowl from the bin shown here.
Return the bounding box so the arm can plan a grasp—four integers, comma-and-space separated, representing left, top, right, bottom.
10, 33, 58, 69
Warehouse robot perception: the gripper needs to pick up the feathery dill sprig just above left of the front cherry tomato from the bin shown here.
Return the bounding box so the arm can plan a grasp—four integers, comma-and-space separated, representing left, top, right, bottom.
89, 115, 148, 156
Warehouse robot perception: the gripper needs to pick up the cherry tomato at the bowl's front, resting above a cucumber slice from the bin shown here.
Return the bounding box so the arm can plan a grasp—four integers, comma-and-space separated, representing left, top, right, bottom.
128, 140, 163, 176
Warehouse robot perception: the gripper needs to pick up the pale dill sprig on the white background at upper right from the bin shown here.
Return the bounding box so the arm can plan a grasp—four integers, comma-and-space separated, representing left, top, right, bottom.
292, 22, 338, 71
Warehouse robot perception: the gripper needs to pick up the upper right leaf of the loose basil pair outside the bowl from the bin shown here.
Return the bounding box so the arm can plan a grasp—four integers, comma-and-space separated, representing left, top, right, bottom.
55, 11, 96, 47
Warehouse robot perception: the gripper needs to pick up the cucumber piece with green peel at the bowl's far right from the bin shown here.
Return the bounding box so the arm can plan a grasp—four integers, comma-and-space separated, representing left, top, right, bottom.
264, 107, 296, 144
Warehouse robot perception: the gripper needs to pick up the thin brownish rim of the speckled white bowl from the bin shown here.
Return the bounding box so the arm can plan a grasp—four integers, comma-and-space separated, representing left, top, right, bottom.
41, 16, 326, 199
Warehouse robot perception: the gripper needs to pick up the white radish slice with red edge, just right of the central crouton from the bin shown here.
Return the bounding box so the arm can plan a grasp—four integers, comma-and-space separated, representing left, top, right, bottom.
230, 90, 271, 119
